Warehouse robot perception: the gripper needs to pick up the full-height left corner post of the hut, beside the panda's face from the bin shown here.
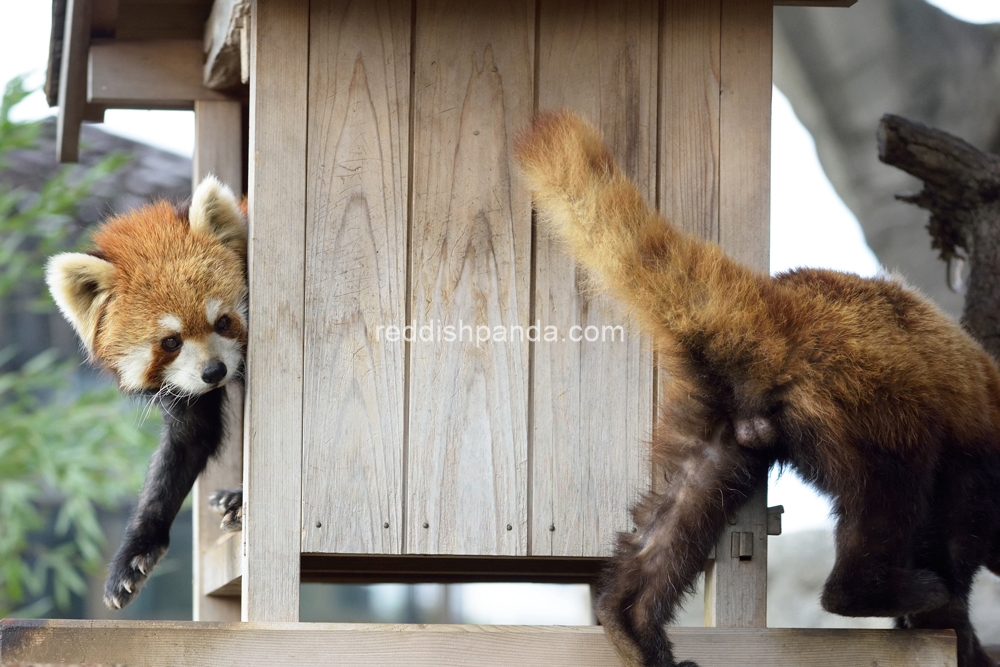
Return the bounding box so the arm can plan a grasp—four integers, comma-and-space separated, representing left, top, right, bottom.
242, 0, 309, 621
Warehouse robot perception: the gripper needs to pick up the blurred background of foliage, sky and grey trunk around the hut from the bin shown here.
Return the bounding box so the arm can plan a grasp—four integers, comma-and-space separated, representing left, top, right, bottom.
0, 0, 1000, 644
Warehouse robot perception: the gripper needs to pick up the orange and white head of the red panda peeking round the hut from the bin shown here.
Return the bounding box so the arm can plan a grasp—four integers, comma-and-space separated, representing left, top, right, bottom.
46, 176, 247, 396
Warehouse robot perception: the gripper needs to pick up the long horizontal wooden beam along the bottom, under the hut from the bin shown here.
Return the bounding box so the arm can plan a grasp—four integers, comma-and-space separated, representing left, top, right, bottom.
0, 620, 958, 667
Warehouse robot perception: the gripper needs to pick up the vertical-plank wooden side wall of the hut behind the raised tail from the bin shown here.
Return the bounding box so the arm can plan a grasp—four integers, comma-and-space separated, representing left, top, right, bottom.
252, 0, 771, 568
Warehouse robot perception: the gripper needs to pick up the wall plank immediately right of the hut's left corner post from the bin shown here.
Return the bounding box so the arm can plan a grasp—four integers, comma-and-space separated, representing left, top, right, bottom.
302, 0, 411, 554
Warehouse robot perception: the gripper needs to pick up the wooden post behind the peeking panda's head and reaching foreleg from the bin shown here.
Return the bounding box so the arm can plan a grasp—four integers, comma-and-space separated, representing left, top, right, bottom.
192, 96, 243, 621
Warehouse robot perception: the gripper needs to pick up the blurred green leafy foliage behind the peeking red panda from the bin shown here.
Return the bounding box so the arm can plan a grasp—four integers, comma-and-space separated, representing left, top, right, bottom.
0, 78, 157, 616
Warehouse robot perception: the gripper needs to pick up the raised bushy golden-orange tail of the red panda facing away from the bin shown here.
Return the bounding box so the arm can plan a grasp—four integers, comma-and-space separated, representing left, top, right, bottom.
515, 111, 769, 363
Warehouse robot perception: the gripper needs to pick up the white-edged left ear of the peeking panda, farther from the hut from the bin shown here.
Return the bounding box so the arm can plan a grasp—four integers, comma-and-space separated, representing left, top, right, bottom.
45, 252, 115, 353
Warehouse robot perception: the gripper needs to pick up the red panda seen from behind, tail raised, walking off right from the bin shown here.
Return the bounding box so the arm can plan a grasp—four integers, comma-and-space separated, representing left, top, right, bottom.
516, 112, 1000, 667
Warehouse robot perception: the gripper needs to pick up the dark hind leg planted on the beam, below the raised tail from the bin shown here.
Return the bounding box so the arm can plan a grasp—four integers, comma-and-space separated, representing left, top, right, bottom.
597, 410, 771, 667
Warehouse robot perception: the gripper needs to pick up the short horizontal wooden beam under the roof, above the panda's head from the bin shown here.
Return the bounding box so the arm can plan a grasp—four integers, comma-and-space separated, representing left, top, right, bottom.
87, 39, 229, 110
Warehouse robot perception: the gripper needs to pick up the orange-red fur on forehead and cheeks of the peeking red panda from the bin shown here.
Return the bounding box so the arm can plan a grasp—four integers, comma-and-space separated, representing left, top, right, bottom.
93, 201, 246, 389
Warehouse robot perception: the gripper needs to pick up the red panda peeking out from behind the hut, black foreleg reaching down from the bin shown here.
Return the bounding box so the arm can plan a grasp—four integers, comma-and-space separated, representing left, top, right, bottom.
46, 176, 247, 608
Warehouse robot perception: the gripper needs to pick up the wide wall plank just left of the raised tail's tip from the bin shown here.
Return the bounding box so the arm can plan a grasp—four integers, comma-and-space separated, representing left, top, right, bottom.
406, 0, 535, 555
